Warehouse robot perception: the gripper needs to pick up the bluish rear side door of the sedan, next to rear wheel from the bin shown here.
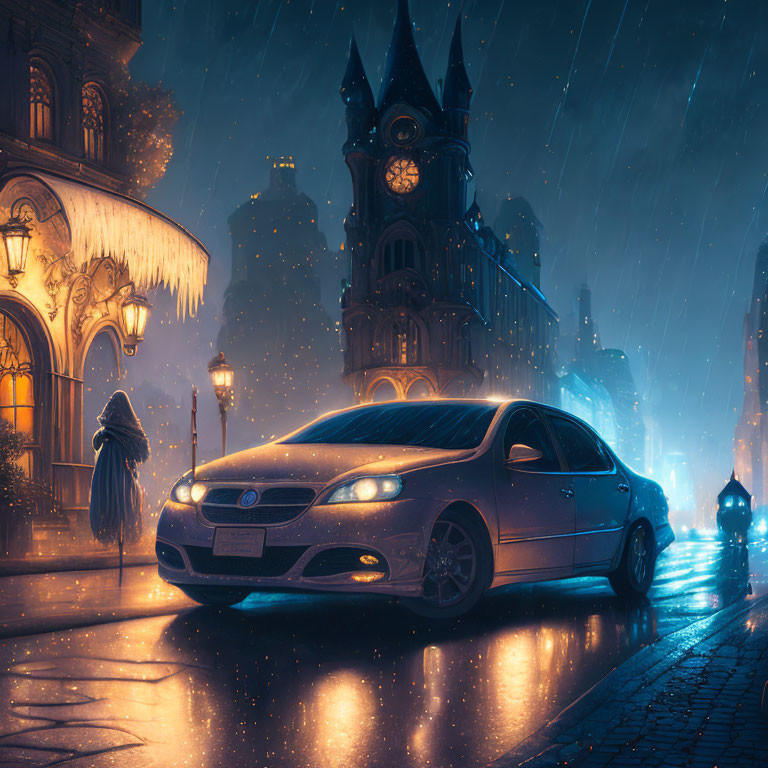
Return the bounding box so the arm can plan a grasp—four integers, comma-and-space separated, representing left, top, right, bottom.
547, 411, 629, 571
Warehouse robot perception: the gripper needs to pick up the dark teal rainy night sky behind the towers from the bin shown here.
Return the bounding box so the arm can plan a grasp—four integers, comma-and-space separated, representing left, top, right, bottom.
114, 0, 768, 507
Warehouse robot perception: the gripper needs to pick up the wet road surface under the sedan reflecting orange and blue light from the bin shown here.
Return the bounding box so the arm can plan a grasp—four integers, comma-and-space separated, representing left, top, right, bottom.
0, 540, 768, 768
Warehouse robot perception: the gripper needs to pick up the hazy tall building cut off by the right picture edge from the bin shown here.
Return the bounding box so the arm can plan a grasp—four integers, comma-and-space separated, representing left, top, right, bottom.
733, 239, 768, 508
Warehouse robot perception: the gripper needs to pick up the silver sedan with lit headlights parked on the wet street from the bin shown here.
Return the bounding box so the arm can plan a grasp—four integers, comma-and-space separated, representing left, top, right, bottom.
156, 399, 674, 617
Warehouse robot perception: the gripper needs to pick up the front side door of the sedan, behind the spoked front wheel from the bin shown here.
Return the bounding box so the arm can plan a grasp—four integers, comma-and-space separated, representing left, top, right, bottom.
494, 406, 576, 578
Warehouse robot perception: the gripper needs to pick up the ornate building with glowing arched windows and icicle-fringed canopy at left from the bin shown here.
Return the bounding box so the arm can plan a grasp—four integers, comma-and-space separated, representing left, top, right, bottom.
0, 0, 208, 536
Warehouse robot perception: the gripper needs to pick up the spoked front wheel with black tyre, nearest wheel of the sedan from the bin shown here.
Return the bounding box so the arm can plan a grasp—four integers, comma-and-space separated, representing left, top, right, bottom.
402, 509, 491, 619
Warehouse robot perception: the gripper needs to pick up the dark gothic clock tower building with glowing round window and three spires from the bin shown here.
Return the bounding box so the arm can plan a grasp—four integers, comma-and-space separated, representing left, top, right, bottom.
341, 0, 558, 401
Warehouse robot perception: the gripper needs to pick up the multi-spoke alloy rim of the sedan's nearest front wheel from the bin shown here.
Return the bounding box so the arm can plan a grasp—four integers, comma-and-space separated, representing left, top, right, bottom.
422, 520, 477, 608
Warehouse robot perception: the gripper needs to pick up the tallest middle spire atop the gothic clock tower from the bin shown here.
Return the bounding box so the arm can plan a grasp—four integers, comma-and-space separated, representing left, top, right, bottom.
378, 0, 441, 116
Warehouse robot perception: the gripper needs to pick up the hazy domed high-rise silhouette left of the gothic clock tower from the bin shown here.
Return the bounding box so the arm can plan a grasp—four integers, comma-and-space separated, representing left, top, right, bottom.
218, 157, 341, 445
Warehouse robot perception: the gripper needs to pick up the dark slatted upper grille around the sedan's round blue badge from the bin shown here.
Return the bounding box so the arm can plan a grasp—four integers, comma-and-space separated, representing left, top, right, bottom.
200, 486, 315, 525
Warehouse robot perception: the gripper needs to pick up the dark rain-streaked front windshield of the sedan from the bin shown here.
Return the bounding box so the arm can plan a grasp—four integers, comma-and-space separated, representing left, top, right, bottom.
282, 402, 499, 449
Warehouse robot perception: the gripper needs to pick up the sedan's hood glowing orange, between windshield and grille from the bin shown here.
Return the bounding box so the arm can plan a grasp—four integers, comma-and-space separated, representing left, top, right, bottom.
190, 443, 474, 484
